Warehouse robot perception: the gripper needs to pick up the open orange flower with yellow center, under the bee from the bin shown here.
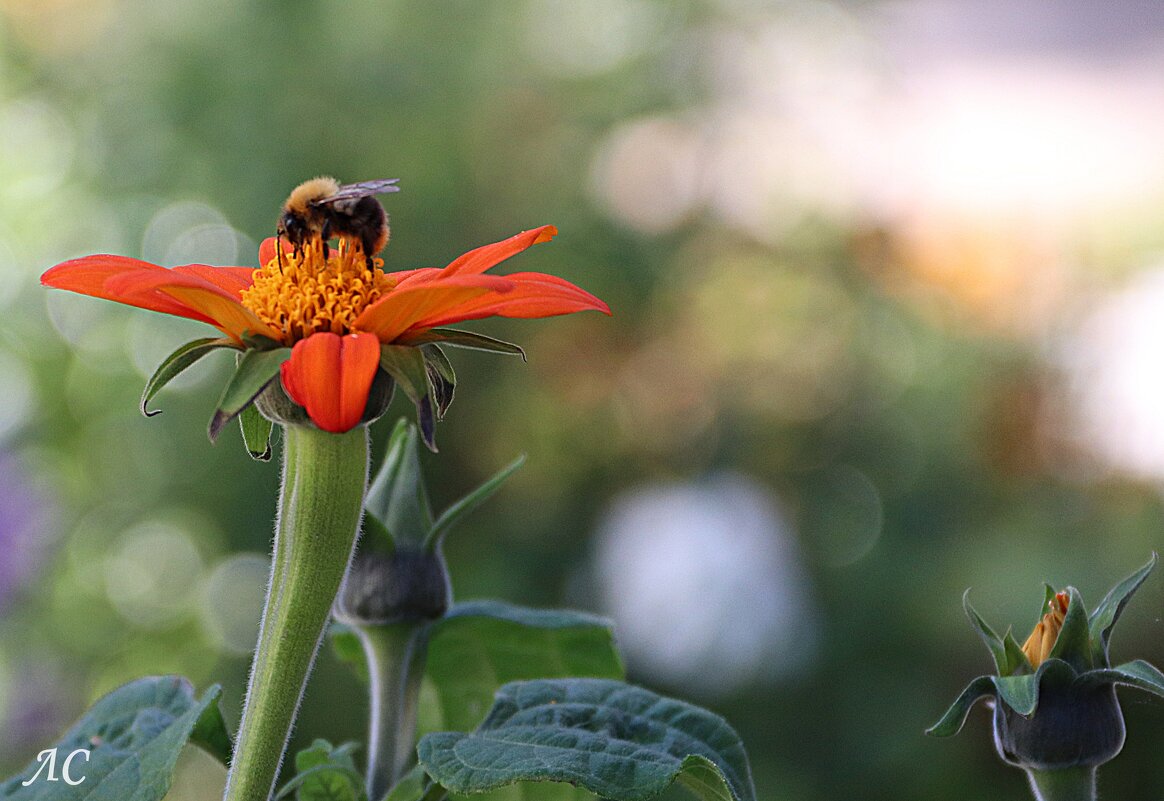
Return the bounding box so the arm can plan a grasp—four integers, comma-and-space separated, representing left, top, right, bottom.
41, 226, 610, 444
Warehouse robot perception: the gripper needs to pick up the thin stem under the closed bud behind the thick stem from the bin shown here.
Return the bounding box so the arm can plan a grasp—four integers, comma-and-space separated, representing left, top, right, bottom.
355, 621, 428, 799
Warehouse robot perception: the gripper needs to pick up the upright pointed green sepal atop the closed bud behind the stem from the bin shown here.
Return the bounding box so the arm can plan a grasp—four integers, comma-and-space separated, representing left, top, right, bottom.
361, 418, 433, 551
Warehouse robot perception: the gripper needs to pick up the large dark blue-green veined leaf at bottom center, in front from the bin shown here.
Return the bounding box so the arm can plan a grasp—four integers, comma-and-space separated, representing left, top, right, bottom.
418, 679, 755, 801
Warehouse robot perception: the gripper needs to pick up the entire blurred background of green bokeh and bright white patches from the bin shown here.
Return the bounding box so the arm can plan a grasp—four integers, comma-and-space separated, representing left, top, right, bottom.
0, 0, 1164, 801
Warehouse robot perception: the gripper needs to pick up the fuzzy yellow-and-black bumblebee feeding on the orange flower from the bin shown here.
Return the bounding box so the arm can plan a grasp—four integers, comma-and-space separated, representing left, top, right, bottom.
276, 177, 400, 268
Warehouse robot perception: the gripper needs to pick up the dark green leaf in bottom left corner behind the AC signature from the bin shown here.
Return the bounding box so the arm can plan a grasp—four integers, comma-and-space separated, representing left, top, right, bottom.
0, 676, 229, 801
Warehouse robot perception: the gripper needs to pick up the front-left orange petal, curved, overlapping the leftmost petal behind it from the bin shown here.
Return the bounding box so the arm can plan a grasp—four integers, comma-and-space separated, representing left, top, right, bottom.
105, 265, 283, 341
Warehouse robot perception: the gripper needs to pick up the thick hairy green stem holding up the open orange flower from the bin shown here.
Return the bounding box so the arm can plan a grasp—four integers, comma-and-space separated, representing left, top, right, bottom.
223, 425, 368, 801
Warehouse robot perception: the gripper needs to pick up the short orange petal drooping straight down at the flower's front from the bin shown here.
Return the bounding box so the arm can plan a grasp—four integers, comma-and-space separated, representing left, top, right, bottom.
279, 333, 379, 434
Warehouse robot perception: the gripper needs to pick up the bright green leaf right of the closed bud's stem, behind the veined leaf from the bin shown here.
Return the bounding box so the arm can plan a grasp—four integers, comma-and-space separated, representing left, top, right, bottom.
425, 601, 625, 731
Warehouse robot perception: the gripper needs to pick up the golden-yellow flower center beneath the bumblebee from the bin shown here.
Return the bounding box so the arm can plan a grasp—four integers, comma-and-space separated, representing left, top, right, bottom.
241, 239, 396, 345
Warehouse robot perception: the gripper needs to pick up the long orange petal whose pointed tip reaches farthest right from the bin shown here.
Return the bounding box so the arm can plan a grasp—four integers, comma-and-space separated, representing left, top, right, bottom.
412, 272, 610, 329
